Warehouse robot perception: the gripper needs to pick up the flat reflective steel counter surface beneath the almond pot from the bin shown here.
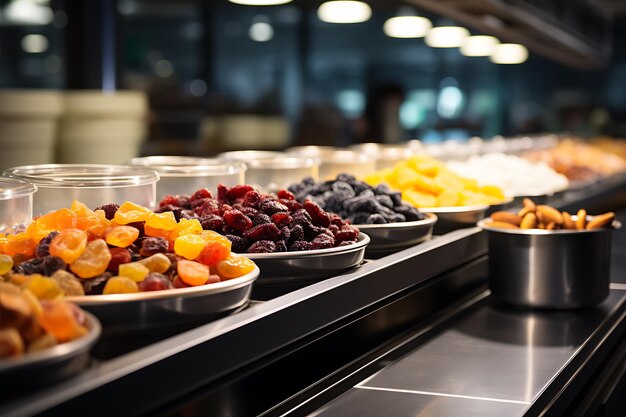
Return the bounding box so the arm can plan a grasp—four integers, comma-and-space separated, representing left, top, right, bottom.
313, 289, 626, 417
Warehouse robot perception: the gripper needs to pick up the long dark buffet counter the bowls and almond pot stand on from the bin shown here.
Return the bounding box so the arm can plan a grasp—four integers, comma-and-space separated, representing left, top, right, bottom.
0, 176, 626, 417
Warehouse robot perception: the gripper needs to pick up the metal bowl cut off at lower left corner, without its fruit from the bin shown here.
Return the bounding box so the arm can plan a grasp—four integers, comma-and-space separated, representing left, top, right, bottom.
0, 312, 102, 394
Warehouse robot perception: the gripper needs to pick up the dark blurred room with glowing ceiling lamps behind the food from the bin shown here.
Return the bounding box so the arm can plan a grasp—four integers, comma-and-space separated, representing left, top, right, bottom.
0, 0, 626, 165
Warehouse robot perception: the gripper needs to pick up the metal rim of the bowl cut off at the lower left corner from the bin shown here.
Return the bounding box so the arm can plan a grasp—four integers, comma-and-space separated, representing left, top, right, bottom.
0, 310, 102, 374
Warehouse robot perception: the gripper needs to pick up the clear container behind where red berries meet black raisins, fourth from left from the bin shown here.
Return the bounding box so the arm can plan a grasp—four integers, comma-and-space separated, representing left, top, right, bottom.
246, 154, 320, 192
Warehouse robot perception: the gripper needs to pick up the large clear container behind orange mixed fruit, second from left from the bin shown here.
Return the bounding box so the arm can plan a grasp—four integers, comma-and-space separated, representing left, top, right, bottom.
4, 164, 159, 216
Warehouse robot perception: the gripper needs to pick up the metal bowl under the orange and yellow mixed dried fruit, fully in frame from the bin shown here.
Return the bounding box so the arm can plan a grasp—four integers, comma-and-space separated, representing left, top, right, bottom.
66, 266, 260, 336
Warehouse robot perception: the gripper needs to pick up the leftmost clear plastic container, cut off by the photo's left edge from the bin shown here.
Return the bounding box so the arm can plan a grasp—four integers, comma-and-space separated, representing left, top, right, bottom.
0, 177, 37, 233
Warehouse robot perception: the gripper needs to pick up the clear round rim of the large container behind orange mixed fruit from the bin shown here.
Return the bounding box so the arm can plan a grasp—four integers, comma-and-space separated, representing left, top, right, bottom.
4, 164, 159, 188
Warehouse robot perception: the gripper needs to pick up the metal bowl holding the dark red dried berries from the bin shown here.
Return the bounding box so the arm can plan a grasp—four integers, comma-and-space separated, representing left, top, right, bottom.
246, 232, 370, 286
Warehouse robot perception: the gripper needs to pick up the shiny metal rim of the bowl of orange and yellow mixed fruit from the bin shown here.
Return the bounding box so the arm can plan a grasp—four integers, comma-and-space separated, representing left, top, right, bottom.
65, 265, 260, 306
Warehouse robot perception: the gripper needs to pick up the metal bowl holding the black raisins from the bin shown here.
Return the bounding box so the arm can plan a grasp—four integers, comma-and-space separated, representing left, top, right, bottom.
355, 213, 437, 256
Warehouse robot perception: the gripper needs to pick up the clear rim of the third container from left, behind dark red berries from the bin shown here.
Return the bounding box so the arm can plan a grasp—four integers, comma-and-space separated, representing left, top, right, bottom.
128, 156, 247, 177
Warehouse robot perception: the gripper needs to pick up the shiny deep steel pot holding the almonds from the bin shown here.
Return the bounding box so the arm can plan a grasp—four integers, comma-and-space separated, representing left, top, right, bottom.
478, 216, 621, 309
